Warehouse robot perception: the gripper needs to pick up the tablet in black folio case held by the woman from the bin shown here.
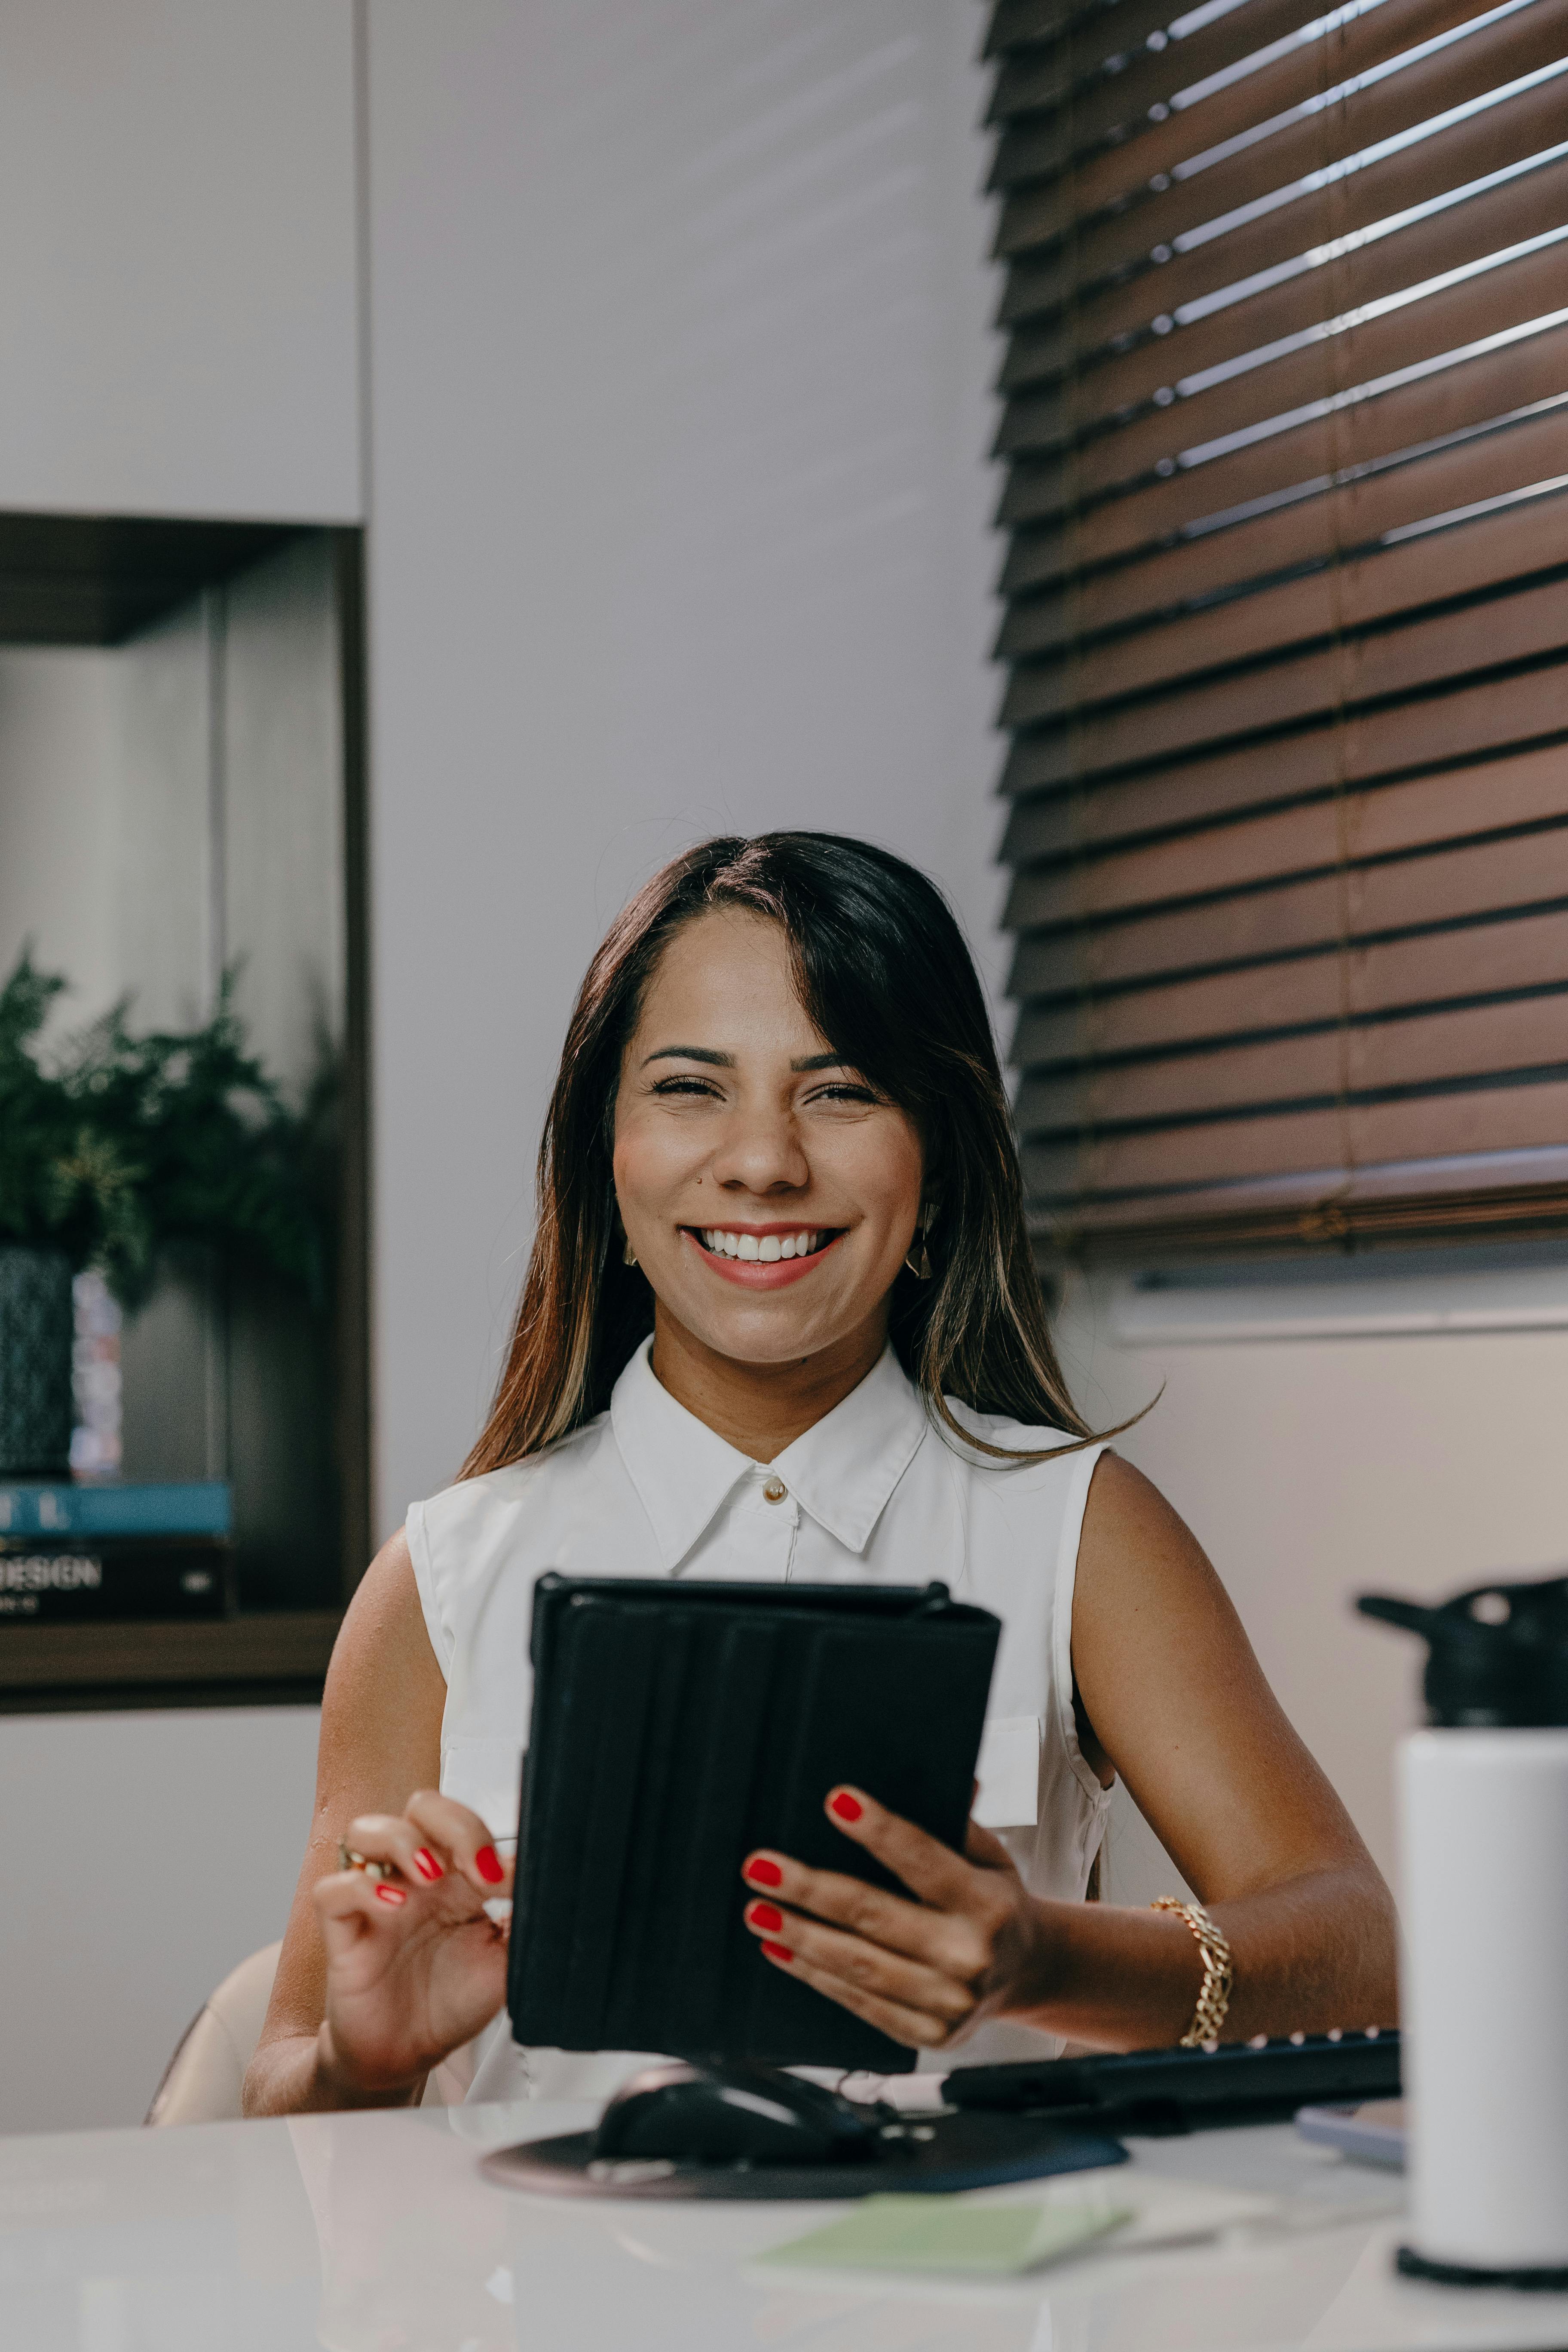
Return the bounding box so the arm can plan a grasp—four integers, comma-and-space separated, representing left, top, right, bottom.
508, 1576, 1001, 2074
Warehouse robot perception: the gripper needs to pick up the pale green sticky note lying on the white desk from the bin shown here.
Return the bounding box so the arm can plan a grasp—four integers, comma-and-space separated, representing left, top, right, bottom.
757, 2197, 1131, 2277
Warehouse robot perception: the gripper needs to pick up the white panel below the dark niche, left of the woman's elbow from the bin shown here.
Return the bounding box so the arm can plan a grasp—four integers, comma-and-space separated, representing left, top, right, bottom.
0, 1708, 317, 2133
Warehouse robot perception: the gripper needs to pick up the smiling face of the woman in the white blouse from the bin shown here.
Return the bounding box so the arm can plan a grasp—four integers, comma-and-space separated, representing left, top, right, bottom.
616, 908, 922, 1364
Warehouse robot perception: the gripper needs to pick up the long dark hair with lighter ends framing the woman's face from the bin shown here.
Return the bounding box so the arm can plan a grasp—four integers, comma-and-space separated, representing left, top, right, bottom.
461, 833, 1091, 1477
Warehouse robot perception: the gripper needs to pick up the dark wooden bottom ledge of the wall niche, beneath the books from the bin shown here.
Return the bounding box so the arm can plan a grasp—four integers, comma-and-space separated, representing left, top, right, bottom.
0, 1609, 341, 1715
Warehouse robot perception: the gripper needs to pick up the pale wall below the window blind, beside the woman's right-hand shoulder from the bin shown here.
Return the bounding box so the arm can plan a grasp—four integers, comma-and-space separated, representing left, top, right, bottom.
1060, 1270, 1568, 1893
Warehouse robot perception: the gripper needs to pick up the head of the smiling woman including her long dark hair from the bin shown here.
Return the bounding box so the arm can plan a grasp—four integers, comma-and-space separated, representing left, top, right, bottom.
463, 833, 1088, 1477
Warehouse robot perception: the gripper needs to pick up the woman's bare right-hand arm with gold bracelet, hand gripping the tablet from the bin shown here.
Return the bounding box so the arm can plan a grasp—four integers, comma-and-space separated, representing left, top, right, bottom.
747, 1456, 1396, 2049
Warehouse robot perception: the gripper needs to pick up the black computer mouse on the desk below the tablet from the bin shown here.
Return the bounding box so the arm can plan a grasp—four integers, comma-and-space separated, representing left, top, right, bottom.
595, 2060, 884, 2164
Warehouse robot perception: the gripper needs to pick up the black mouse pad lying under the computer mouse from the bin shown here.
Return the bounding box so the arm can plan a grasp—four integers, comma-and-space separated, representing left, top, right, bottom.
484, 2114, 1126, 2202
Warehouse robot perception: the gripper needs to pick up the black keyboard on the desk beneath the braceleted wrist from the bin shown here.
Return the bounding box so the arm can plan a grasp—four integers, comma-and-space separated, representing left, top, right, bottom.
945, 2027, 1401, 2133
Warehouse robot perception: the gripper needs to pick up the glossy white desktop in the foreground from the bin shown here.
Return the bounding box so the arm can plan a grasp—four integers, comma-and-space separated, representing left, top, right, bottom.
0, 2105, 1568, 2352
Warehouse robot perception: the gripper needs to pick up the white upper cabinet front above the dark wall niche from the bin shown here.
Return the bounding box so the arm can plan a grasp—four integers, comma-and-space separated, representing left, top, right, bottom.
0, 0, 360, 522
